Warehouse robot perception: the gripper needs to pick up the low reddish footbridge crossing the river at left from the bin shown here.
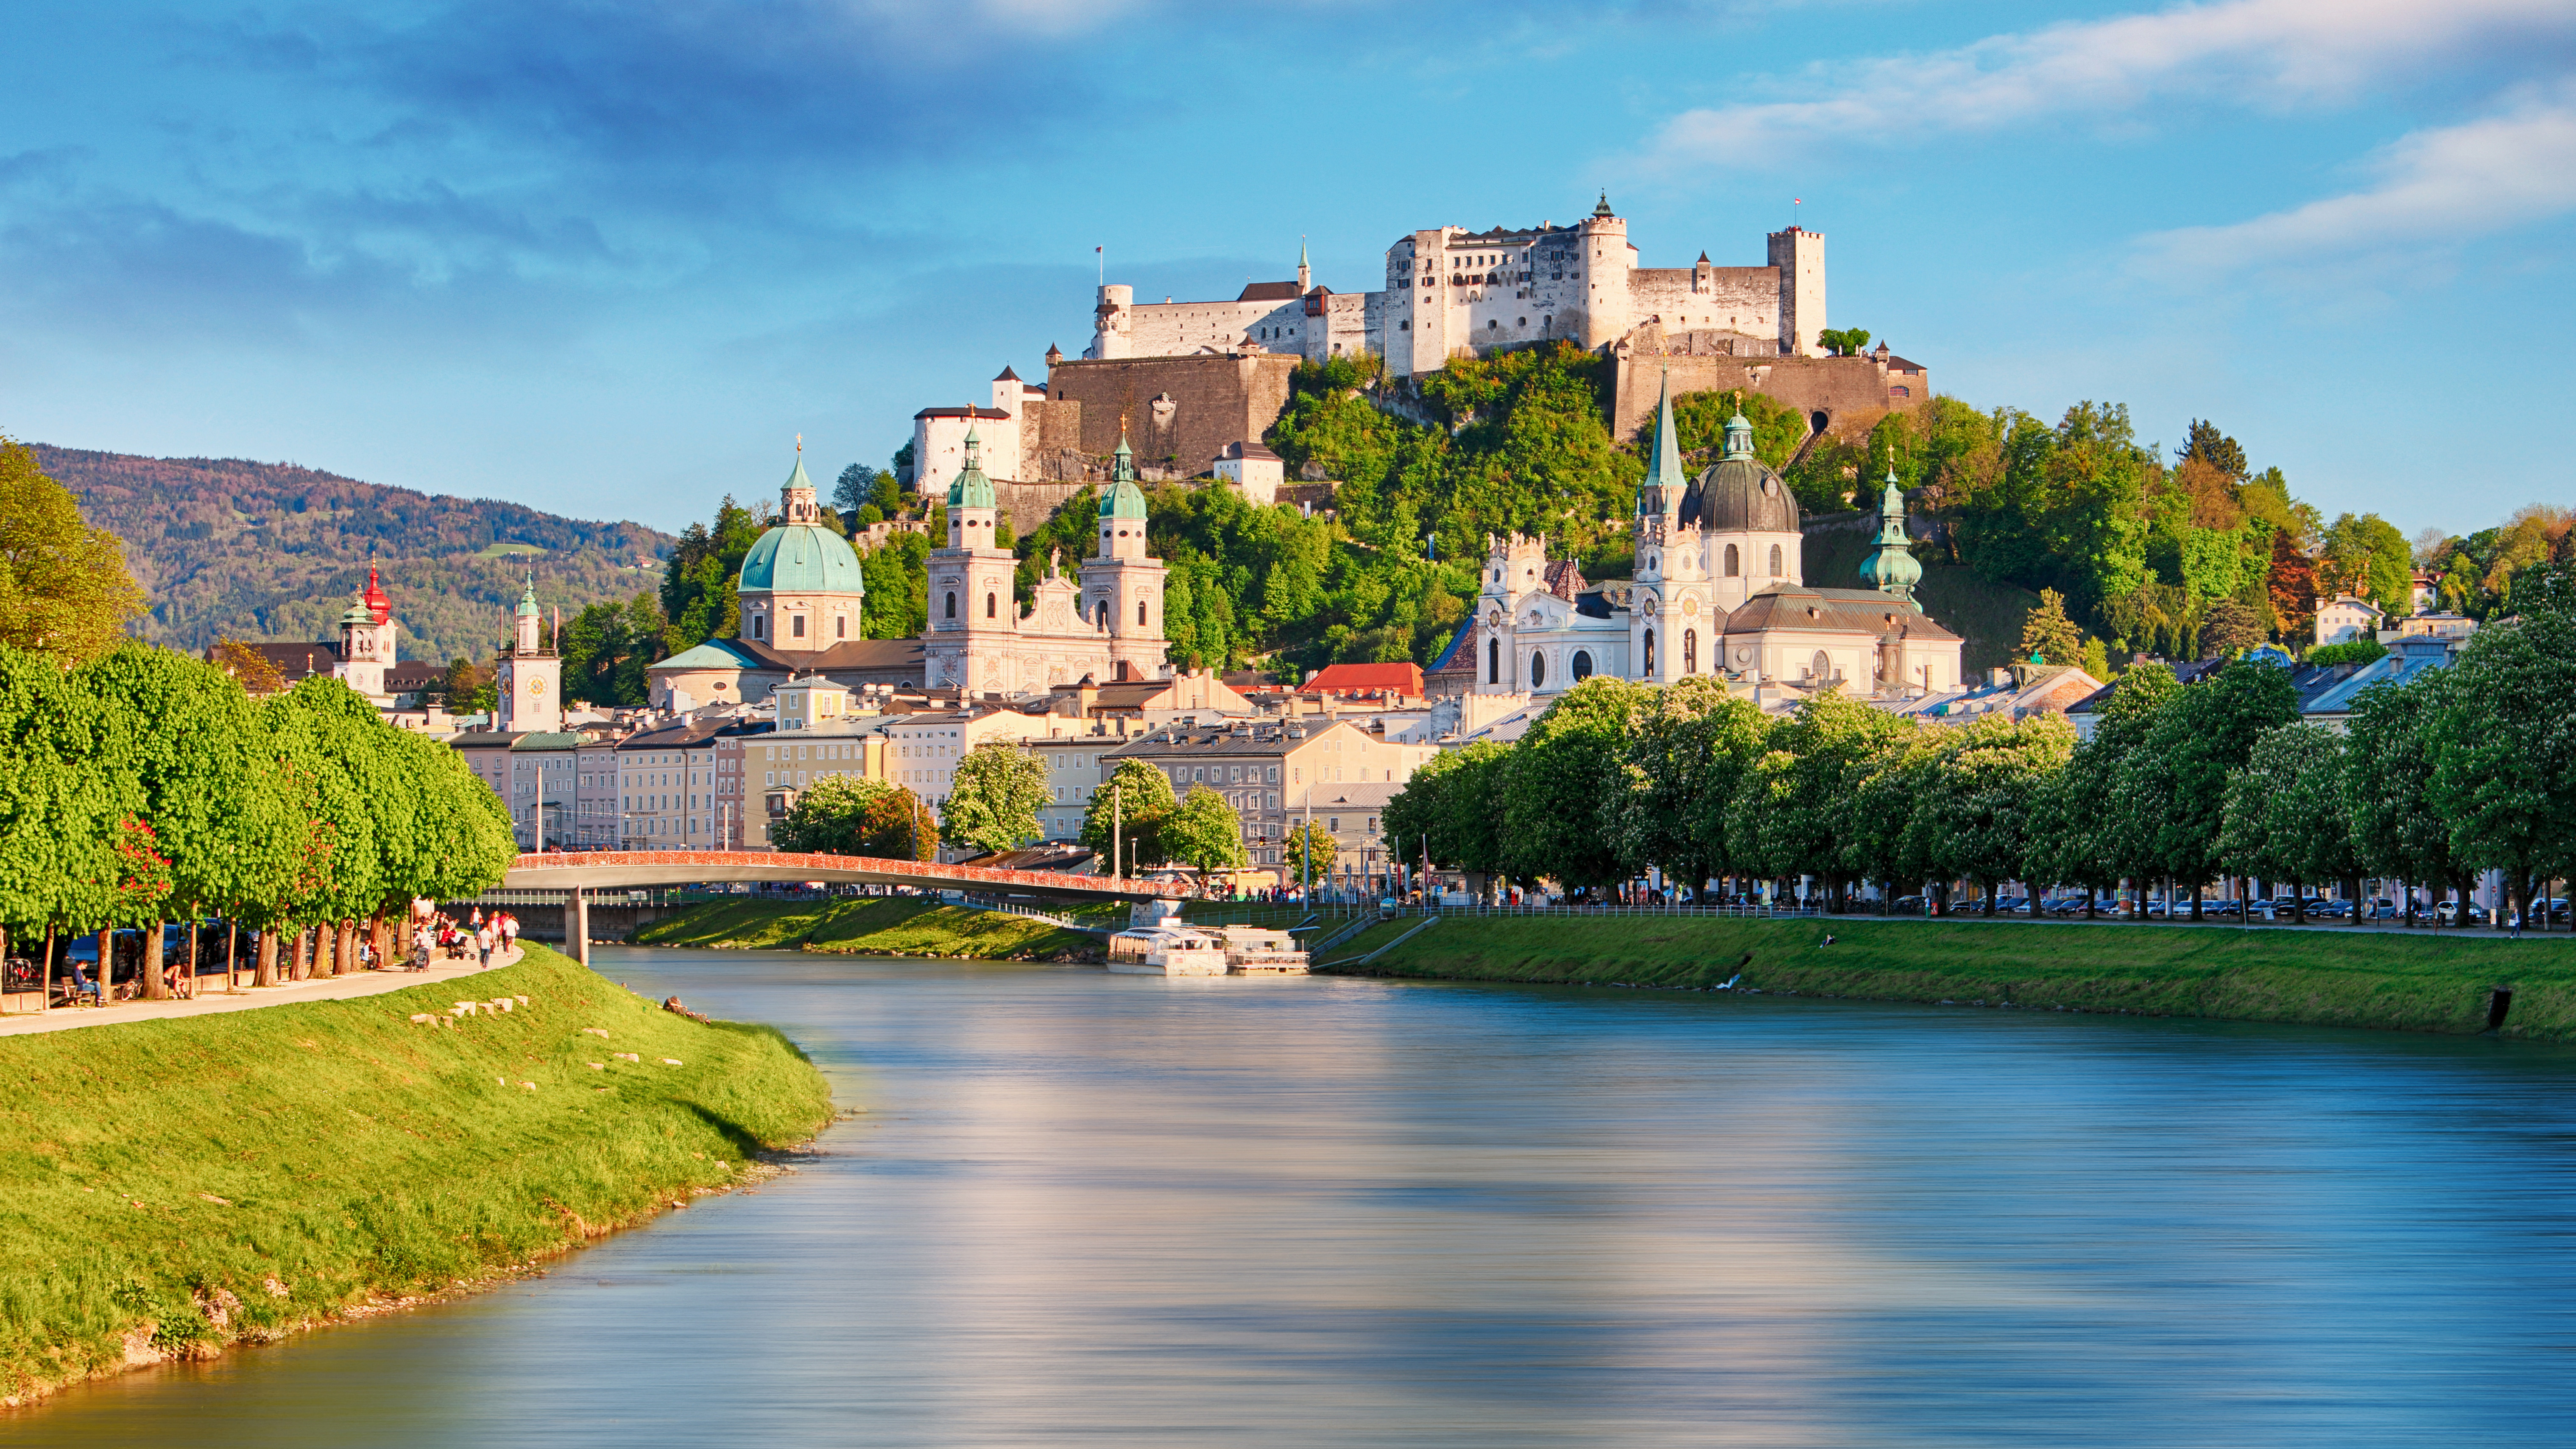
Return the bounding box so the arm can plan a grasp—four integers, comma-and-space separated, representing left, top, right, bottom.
500, 851, 1185, 900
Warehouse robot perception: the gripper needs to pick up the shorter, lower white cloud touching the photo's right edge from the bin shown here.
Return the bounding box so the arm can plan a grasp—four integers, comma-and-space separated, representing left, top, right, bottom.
2141, 83, 2576, 273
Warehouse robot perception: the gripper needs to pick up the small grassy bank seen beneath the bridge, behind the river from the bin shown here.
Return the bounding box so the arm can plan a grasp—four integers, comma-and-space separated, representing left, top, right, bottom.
634, 895, 1100, 962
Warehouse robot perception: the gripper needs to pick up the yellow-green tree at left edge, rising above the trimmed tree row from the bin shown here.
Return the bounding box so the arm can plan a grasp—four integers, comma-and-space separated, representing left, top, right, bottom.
0, 436, 144, 663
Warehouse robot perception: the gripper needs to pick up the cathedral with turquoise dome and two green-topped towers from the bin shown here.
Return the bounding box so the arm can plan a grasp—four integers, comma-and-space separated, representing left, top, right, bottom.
647, 430, 1172, 709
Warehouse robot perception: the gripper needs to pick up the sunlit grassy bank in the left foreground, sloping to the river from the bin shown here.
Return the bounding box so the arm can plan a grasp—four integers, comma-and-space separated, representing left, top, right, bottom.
0, 944, 832, 1403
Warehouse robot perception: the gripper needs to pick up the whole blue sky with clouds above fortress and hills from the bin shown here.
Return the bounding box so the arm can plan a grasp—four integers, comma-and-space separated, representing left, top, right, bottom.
0, 0, 2576, 534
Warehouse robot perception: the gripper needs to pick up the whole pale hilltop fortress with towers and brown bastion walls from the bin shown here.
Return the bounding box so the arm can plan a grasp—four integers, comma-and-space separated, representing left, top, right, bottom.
912, 196, 1932, 505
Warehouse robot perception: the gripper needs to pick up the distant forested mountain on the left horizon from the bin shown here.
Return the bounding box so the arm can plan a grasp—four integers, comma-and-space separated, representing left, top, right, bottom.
28, 444, 675, 660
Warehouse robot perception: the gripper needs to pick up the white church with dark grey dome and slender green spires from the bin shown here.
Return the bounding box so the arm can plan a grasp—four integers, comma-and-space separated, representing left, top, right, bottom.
1476, 371, 1960, 696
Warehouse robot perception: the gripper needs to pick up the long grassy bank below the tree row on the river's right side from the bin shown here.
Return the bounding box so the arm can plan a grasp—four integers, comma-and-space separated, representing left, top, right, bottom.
1329, 915, 2576, 1041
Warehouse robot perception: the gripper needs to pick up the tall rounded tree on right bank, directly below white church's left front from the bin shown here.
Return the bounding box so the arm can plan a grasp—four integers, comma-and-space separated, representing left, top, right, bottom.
1502, 676, 1649, 887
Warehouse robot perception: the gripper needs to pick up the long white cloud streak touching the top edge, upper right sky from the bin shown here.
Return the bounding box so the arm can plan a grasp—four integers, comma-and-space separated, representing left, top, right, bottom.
1644, 0, 2576, 170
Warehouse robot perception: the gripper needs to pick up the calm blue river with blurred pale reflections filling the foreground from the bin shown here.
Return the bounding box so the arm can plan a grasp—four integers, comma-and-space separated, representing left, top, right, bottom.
0, 952, 2576, 1449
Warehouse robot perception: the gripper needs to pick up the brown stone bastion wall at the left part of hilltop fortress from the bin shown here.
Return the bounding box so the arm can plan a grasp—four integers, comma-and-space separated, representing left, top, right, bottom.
1046, 353, 1298, 477
